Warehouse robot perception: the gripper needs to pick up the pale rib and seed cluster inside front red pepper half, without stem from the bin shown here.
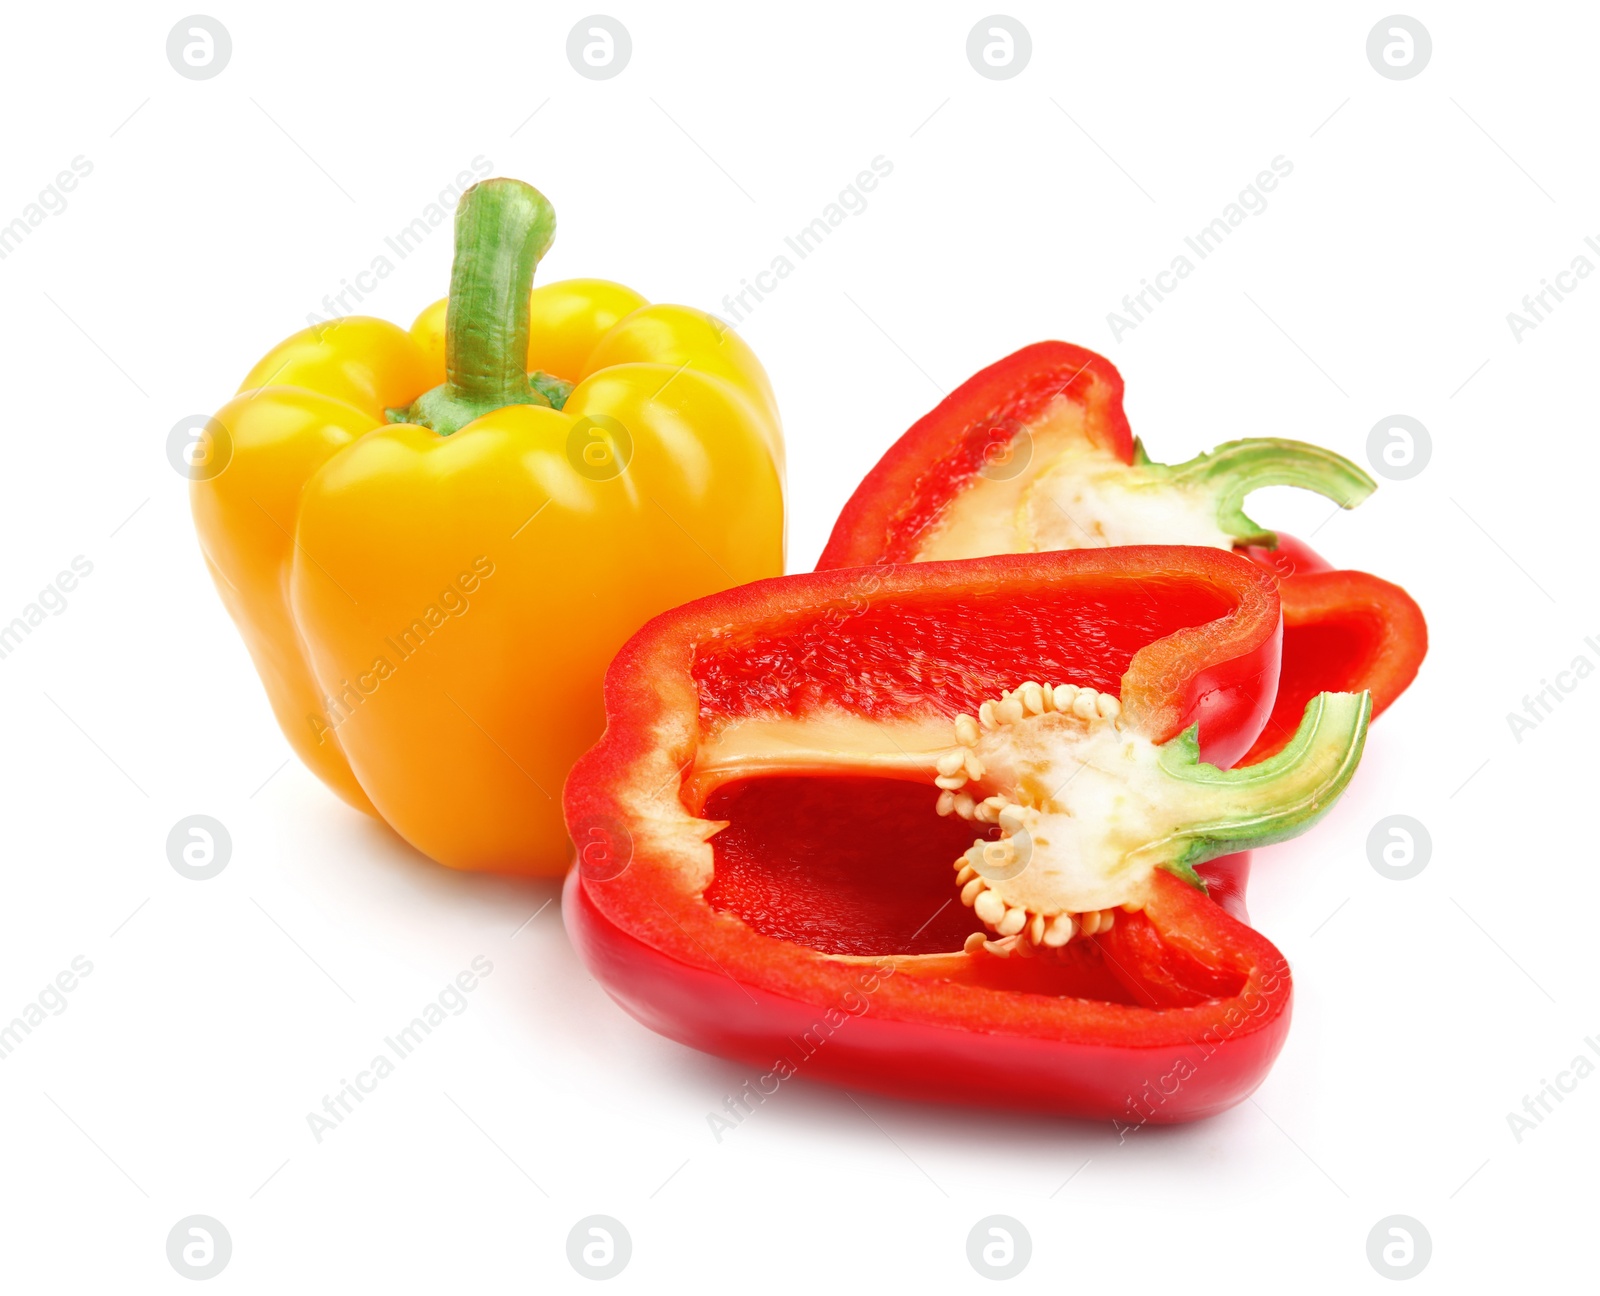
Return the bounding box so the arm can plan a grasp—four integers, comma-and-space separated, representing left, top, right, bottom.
683, 683, 1187, 957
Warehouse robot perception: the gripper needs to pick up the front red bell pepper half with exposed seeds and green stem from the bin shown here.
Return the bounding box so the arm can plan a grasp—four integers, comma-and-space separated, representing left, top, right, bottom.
565, 546, 1370, 1123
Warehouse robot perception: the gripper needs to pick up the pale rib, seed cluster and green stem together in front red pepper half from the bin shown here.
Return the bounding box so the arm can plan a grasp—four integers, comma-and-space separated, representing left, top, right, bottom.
680, 682, 1366, 957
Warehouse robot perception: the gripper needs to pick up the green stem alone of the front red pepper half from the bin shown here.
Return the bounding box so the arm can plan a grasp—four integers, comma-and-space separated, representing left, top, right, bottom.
1144, 693, 1373, 885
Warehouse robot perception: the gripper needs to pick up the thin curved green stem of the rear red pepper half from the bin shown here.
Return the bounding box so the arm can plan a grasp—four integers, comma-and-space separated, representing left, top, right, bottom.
1147, 437, 1378, 547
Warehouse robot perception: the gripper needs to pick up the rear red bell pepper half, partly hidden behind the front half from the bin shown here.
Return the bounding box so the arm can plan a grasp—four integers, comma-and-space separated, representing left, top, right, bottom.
818, 342, 1427, 763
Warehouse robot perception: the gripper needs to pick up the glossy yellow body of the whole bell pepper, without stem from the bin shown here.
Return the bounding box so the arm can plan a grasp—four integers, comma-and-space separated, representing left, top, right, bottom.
192, 280, 784, 874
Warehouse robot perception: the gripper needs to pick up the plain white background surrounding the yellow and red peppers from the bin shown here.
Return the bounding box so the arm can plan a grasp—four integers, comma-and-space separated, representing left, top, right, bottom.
0, 0, 1600, 1293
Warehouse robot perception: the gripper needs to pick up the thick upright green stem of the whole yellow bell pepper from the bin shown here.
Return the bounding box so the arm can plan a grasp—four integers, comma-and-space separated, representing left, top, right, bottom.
392, 179, 555, 437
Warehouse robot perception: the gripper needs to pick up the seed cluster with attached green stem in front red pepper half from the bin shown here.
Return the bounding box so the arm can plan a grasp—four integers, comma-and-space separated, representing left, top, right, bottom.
934, 683, 1371, 946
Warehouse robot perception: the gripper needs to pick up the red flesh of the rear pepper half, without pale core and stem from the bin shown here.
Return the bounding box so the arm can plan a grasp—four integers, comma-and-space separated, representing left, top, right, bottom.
818, 342, 1427, 763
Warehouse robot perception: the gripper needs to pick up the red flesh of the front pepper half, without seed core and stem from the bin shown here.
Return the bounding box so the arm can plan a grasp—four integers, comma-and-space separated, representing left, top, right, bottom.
565, 546, 1354, 1123
